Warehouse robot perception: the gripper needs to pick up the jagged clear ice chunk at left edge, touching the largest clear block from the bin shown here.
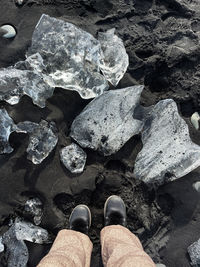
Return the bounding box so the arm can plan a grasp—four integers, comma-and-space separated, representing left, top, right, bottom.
0, 53, 54, 108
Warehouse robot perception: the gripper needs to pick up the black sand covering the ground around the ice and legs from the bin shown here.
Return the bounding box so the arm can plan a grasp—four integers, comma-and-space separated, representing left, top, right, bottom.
0, 0, 200, 267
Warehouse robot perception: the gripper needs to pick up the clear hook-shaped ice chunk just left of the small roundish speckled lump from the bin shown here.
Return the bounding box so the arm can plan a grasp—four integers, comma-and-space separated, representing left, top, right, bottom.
17, 120, 58, 164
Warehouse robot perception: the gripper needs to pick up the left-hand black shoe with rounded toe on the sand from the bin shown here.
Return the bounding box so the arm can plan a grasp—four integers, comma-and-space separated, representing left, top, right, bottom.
69, 205, 91, 234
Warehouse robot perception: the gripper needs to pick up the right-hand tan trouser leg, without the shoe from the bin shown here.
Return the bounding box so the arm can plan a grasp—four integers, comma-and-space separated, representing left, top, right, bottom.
101, 225, 155, 267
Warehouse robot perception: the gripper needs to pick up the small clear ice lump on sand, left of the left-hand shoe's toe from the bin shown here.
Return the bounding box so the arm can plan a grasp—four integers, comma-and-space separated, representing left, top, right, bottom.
24, 198, 43, 225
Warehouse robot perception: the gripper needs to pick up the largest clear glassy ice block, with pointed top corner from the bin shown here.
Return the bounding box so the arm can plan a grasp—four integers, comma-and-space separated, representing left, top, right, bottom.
28, 14, 108, 99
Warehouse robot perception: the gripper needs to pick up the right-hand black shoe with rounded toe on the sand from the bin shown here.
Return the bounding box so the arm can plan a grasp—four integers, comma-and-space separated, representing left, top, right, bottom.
104, 195, 126, 226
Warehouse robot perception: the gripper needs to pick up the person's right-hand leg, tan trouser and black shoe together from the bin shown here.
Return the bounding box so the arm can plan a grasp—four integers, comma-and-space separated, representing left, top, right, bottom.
101, 196, 155, 267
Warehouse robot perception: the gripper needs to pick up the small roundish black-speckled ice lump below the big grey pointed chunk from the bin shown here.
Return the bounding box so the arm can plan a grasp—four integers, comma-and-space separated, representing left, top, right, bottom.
60, 143, 87, 173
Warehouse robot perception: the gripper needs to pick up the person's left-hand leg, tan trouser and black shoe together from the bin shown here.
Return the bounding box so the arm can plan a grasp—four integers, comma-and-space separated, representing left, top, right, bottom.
37, 205, 93, 267
